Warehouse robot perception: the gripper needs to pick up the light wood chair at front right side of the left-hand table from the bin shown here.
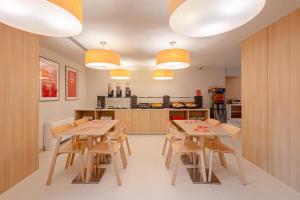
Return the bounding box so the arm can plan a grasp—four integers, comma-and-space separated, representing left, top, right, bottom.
85, 130, 126, 186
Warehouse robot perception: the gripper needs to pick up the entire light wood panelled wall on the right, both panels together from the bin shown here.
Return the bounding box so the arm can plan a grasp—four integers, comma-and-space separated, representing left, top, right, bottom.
242, 9, 300, 191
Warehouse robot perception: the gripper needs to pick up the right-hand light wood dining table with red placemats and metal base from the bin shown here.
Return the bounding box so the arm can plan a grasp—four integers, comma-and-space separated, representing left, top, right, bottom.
173, 120, 237, 184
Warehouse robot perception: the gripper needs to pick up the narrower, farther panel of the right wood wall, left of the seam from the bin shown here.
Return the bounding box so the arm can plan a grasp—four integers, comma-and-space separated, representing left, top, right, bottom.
242, 29, 268, 170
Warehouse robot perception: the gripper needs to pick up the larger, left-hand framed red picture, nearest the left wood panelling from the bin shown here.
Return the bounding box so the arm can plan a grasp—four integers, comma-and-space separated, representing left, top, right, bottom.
40, 57, 59, 101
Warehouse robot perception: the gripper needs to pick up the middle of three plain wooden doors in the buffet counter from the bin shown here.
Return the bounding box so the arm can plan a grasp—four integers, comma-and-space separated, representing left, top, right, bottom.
132, 110, 150, 133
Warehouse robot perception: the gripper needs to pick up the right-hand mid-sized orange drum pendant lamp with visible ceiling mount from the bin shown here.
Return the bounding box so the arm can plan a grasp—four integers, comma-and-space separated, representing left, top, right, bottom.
156, 42, 190, 69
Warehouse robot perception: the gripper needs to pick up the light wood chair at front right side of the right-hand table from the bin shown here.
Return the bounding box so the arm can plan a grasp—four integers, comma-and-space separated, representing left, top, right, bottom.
205, 124, 246, 185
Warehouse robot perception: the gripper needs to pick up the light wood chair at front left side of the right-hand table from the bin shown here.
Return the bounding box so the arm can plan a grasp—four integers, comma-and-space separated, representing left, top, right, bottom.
169, 127, 207, 185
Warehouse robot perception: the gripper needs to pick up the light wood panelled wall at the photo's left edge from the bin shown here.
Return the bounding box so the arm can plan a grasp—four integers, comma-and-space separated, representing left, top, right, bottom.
0, 23, 39, 193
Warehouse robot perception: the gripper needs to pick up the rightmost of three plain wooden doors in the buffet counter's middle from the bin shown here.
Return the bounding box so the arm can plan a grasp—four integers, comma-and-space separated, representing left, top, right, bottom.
149, 110, 169, 134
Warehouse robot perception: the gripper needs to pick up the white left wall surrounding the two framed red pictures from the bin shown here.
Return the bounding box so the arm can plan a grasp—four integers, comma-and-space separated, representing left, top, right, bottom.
39, 47, 86, 148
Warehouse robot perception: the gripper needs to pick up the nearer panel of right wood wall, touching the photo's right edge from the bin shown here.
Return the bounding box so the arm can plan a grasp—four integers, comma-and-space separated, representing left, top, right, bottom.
268, 9, 300, 191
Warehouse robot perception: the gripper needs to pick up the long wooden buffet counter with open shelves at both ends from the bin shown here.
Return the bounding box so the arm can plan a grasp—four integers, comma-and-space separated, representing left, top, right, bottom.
75, 108, 210, 134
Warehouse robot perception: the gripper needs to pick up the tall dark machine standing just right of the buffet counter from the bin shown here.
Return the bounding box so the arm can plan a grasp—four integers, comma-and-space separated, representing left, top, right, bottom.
208, 88, 227, 123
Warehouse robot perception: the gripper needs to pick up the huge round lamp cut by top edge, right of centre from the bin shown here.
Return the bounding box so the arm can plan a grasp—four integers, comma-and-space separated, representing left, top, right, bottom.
169, 0, 266, 37
